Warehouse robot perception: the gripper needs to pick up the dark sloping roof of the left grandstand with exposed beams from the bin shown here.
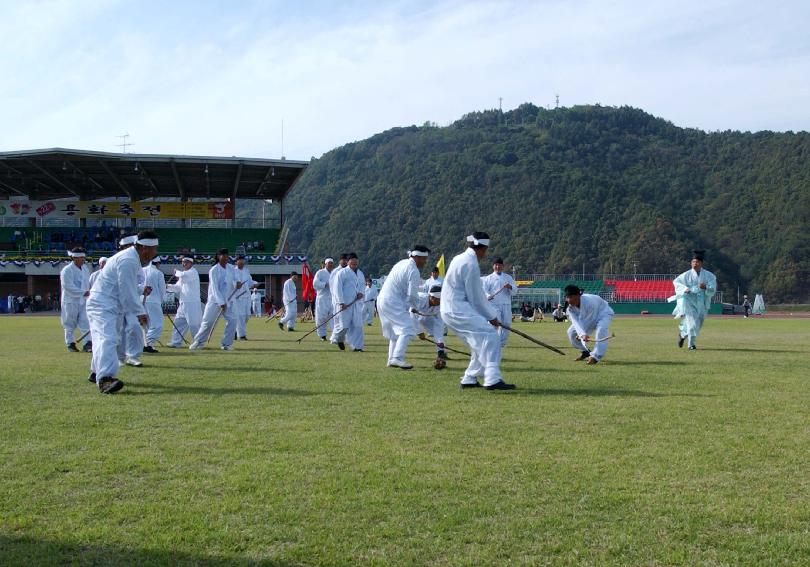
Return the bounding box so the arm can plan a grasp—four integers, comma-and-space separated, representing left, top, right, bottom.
0, 148, 308, 201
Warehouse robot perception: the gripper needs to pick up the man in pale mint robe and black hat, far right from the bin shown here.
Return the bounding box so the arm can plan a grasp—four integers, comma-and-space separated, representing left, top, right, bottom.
668, 250, 717, 350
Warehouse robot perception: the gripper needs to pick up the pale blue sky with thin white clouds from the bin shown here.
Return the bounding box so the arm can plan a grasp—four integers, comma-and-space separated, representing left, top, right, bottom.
0, 0, 810, 160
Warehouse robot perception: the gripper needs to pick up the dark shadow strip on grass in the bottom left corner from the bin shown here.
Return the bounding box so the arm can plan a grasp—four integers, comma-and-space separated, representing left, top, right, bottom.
0, 536, 290, 567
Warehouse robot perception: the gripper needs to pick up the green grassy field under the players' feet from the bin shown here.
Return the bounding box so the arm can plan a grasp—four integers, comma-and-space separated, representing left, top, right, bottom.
0, 317, 810, 566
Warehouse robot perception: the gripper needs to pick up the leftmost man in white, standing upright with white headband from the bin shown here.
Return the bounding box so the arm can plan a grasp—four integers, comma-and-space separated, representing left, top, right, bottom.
59, 247, 92, 352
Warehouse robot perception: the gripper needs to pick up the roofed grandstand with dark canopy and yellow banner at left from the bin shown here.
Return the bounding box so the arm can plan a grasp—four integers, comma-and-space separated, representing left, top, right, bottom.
0, 148, 308, 310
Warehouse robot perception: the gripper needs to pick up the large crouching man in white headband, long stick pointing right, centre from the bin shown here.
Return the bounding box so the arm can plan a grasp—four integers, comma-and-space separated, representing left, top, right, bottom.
441, 232, 515, 390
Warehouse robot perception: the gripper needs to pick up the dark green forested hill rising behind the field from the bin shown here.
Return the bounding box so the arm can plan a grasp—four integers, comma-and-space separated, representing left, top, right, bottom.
285, 104, 810, 302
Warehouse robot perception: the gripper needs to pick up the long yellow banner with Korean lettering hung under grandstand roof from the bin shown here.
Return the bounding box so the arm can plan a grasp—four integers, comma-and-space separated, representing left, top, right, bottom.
0, 201, 234, 219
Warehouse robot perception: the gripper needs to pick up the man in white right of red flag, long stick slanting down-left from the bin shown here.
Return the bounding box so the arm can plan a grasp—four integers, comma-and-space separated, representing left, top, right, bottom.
332, 252, 366, 352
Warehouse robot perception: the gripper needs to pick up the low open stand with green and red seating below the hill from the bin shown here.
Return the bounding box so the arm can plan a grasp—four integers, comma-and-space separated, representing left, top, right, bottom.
512, 274, 723, 314
